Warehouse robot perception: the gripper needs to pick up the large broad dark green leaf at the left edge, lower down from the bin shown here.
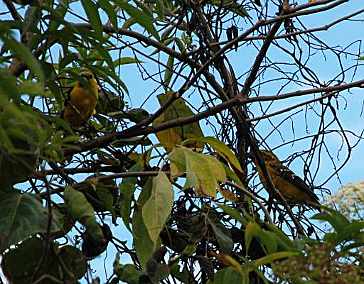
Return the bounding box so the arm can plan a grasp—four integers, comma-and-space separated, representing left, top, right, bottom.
0, 190, 61, 252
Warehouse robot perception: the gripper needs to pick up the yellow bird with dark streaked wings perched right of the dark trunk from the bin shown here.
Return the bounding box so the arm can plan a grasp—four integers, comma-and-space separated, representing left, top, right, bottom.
256, 150, 320, 208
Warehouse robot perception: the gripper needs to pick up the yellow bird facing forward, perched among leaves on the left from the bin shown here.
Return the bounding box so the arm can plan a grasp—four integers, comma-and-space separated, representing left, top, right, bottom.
61, 71, 99, 127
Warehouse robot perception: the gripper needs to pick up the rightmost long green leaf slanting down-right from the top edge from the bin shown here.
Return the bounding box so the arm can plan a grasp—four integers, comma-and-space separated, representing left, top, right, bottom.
114, 0, 159, 40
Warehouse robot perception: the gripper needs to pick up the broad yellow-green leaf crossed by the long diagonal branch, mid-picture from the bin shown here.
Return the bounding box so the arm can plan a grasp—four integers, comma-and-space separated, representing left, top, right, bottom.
153, 92, 203, 152
